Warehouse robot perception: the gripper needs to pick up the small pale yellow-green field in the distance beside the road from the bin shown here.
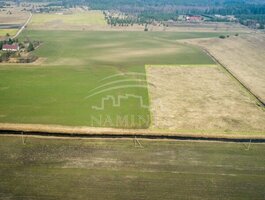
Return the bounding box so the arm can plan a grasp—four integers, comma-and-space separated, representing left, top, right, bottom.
30, 11, 107, 26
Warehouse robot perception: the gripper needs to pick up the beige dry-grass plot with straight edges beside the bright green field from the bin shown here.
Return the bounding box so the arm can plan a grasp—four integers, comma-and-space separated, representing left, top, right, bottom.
146, 66, 265, 132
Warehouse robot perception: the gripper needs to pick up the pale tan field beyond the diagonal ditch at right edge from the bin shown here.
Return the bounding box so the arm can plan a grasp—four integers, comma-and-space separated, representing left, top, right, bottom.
183, 33, 265, 103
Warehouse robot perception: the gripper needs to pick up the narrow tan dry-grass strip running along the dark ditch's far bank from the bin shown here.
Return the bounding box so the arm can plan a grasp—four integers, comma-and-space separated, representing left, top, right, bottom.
0, 123, 265, 140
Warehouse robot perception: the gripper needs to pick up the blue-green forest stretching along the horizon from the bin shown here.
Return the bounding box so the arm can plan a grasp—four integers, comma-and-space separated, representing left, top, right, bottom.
0, 0, 265, 29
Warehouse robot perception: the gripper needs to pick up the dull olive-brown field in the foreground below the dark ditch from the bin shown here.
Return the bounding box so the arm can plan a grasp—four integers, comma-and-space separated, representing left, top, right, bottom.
0, 136, 265, 200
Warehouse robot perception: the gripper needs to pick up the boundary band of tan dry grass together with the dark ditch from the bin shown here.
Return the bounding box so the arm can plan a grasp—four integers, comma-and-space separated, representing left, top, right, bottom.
0, 123, 265, 142
